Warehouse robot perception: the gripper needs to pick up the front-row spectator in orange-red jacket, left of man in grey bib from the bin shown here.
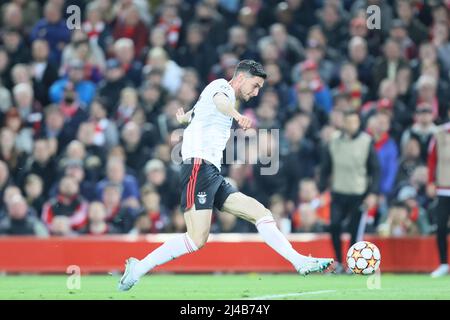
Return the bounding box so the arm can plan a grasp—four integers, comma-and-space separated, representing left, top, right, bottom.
291, 178, 331, 232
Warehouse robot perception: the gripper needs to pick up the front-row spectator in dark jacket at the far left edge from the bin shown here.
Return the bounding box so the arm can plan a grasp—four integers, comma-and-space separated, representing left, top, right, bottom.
0, 195, 48, 237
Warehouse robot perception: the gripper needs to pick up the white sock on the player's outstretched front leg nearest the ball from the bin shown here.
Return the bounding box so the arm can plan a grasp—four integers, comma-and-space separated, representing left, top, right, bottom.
255, 216, 308, 270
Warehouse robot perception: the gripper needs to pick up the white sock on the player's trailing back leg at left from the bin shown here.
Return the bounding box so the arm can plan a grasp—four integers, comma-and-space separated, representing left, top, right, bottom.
133, 232, 198, 279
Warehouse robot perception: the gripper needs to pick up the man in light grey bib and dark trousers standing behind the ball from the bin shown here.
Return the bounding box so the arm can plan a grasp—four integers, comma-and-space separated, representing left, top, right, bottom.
319, 111, 380, 272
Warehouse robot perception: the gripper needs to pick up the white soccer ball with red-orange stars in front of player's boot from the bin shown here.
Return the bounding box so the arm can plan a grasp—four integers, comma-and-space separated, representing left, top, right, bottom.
347, 241, 381, 274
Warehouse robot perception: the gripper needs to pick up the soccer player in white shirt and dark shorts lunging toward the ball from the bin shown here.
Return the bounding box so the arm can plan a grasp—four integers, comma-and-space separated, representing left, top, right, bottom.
118, 60, 333, 291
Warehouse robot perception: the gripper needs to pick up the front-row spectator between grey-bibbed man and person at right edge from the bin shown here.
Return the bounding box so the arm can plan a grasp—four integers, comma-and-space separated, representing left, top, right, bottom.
378, 202, 419, 237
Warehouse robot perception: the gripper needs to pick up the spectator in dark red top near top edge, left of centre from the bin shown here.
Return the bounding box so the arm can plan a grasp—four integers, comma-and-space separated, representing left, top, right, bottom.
113, 5, 148, 58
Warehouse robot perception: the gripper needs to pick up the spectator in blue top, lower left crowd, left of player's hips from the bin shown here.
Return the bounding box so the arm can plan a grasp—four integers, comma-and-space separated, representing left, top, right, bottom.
97, 158, 139, 208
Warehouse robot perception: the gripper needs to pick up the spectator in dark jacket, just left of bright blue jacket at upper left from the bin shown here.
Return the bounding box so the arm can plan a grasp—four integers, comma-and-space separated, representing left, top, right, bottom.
30, 39, 58, 106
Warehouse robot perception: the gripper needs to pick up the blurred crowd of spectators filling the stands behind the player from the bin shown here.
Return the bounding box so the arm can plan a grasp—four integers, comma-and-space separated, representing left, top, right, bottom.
0, 0, 450, 236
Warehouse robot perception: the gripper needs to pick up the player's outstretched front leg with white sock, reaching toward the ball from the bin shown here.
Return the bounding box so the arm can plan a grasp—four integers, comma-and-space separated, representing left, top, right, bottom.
217, 191, 332, 274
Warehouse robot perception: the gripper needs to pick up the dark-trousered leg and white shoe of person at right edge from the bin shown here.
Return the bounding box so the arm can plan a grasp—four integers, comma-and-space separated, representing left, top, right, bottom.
431, 197, 450, 277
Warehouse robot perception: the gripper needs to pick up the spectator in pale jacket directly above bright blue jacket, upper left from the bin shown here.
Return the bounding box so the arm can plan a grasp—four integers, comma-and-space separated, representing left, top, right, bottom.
60, 30, 105, 83
